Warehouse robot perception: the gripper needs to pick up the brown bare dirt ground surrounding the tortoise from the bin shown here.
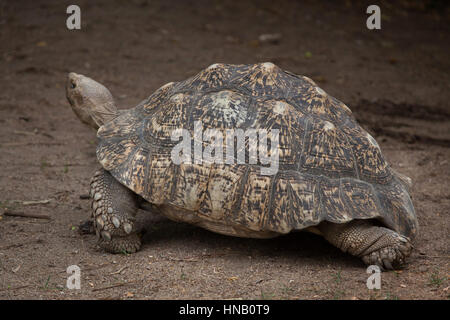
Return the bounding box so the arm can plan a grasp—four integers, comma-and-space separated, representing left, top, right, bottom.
0, 0, 450, 299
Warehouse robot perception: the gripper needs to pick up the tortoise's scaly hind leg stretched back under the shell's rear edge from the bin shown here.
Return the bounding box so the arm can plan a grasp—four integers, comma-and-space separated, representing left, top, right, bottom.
319, 220, 412, 269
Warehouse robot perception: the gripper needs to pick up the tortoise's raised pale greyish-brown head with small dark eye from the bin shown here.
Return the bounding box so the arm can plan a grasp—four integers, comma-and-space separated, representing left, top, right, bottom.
66, 72, 118, 130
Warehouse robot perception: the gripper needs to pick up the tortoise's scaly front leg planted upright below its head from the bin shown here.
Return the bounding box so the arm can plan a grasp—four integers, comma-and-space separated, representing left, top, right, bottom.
90, 168, 141, 253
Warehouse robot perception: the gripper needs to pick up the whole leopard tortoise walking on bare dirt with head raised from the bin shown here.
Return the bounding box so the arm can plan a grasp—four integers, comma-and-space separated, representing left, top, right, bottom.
66, 62, 418, 269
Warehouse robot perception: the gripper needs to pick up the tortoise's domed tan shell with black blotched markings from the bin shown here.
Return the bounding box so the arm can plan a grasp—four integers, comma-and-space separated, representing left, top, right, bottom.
97, 63, 418, 238
